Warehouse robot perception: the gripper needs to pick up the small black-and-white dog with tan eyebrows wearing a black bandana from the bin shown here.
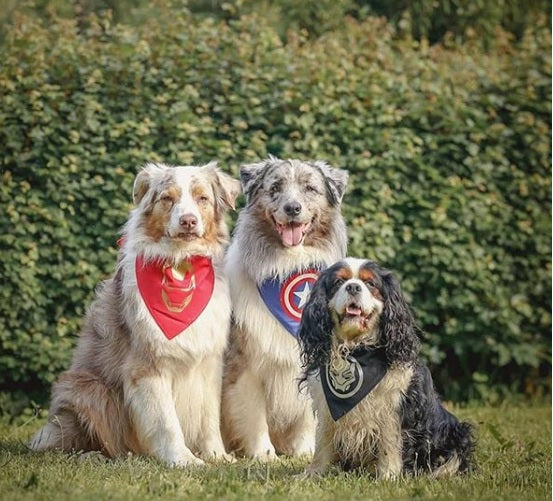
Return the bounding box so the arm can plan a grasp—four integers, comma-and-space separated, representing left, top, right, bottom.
299, 258, 474, 478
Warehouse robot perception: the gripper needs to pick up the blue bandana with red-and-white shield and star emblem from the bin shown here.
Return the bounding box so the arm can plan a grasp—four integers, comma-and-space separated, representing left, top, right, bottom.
257, 266, 320, 337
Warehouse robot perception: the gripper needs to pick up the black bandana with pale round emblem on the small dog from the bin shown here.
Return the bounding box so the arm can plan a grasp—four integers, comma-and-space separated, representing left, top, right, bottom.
319, 348, 388, 421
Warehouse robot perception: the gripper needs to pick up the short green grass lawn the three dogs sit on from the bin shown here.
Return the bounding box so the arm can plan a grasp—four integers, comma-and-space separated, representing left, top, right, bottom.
0, 402, 551, 501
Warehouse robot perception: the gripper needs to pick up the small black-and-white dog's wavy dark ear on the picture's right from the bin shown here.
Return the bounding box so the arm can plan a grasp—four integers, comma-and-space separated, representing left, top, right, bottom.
380, 270, 420, 363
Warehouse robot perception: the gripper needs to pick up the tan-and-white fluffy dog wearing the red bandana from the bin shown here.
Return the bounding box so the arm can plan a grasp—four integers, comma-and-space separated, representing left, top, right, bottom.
30, 163, 240, 466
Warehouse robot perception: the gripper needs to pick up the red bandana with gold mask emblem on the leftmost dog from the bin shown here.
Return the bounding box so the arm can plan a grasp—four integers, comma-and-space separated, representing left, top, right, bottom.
135, 256, 215, 339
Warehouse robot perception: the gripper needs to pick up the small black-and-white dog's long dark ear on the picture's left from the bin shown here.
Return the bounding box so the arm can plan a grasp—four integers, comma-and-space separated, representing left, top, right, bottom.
298, 270, 334, 382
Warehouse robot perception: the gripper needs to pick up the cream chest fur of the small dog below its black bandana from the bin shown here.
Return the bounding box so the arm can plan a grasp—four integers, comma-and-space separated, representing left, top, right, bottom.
316, 364, 413, 466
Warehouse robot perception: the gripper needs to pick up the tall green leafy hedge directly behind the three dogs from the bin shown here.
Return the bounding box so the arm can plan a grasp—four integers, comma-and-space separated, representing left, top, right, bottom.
0, 10, 551, 406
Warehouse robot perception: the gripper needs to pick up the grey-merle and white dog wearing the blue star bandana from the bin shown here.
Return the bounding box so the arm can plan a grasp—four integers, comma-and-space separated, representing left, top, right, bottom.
222, 157, 347, 460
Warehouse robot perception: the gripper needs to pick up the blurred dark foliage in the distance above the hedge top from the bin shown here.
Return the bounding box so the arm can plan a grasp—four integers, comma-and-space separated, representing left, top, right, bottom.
4, 0, 551, 47
